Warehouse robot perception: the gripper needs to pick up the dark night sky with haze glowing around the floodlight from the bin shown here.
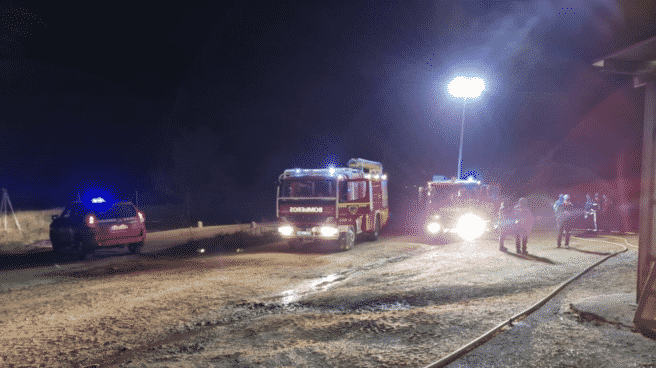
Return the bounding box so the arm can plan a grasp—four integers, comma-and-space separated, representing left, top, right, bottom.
0, 0, 656, 218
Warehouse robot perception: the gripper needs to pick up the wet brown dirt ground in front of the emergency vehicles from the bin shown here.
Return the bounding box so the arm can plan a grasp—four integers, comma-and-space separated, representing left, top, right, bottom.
0, 233, 656, 367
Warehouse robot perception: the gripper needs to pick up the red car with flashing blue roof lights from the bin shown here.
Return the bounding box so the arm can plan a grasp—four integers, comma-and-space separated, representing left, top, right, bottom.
50, 198, 147, 259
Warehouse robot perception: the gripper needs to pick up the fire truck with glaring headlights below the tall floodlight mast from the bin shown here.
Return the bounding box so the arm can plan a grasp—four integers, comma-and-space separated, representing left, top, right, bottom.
418, 176, 498, 240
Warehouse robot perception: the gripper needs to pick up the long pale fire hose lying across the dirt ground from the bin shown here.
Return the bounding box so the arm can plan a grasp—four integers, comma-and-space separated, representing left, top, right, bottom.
424, 238, 629, 368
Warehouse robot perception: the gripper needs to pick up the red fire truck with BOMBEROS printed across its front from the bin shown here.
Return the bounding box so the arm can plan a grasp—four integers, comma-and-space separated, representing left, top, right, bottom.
276, 158, 389, 250
